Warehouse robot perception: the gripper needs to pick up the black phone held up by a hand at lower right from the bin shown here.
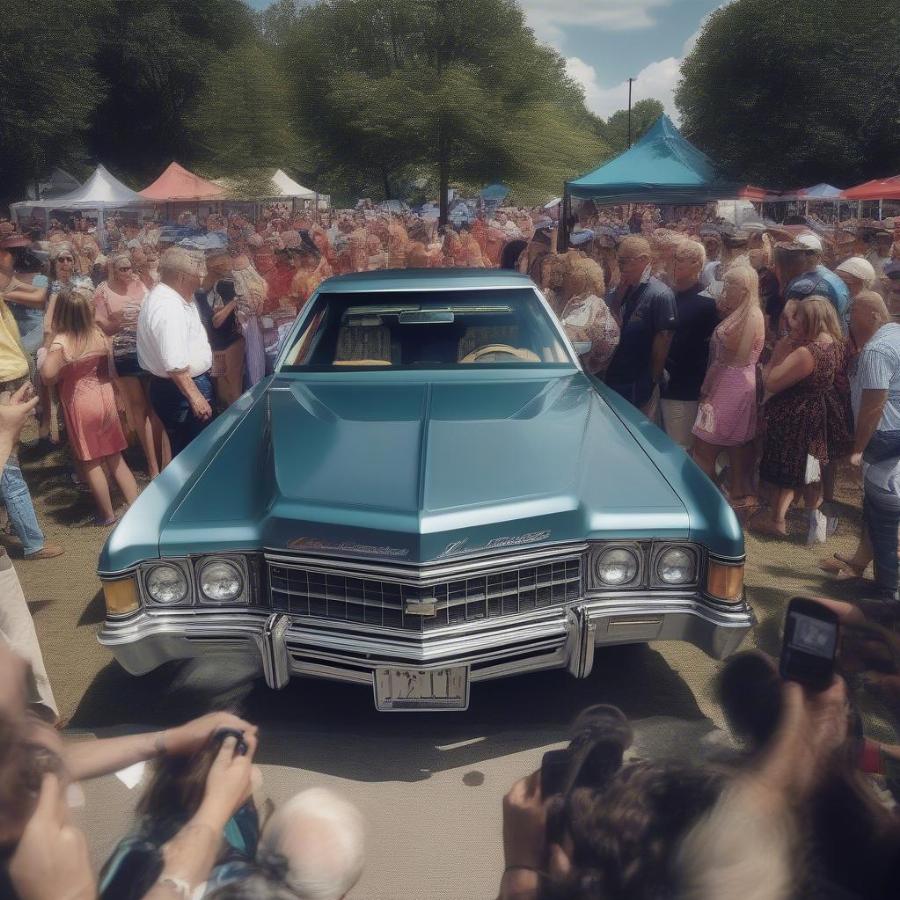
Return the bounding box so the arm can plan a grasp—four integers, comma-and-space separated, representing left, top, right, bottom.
779, 597, 839, 691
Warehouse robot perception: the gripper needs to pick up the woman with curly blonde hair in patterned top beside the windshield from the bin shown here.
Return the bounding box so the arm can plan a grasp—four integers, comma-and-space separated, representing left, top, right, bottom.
559, 257, 619, 377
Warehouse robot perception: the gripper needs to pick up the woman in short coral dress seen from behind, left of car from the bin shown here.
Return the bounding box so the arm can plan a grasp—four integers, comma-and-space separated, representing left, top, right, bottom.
40, 285, 138, 525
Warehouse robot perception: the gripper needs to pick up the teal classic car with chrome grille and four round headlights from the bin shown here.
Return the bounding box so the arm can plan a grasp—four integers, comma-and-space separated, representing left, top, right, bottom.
99, 270, 753, 710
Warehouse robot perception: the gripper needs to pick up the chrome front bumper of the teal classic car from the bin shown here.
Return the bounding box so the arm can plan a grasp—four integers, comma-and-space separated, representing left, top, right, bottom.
99, 592, 755, 688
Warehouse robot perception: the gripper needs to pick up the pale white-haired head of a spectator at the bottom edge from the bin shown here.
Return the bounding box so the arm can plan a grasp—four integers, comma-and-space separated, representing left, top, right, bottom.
259, 788, 365, 900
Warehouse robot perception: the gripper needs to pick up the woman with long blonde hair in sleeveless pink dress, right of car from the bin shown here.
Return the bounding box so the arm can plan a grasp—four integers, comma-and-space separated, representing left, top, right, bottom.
692, 265, 766, 509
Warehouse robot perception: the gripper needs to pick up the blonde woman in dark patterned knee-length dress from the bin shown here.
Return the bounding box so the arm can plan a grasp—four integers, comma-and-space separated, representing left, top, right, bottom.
751, 295, 847, 543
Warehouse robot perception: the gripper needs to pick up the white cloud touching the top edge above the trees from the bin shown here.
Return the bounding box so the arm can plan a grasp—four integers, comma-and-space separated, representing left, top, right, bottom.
520, 0, 673, 45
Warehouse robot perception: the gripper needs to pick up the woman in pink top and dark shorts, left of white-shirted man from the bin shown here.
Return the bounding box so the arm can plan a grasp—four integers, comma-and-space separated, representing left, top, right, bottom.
94, 253, 171, 478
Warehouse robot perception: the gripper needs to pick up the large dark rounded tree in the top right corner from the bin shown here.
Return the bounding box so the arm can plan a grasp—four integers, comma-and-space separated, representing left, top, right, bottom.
676, 0, 900, 188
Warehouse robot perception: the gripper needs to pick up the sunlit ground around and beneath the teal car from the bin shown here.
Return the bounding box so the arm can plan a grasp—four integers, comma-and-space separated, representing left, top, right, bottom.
6, 451, 891, 900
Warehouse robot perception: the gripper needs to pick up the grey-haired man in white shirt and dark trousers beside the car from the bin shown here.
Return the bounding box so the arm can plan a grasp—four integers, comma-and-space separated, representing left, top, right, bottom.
137, 247, 213, 456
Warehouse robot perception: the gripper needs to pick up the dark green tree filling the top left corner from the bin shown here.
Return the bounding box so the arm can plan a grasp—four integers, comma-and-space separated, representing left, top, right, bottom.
0, 0, 111, 201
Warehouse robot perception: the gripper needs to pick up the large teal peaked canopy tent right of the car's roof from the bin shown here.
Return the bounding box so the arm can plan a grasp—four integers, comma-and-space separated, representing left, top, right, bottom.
560, 115, 743, 249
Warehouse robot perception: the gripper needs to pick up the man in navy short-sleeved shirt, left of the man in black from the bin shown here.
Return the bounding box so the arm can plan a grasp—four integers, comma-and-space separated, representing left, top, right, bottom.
606, 235, 677, 420
